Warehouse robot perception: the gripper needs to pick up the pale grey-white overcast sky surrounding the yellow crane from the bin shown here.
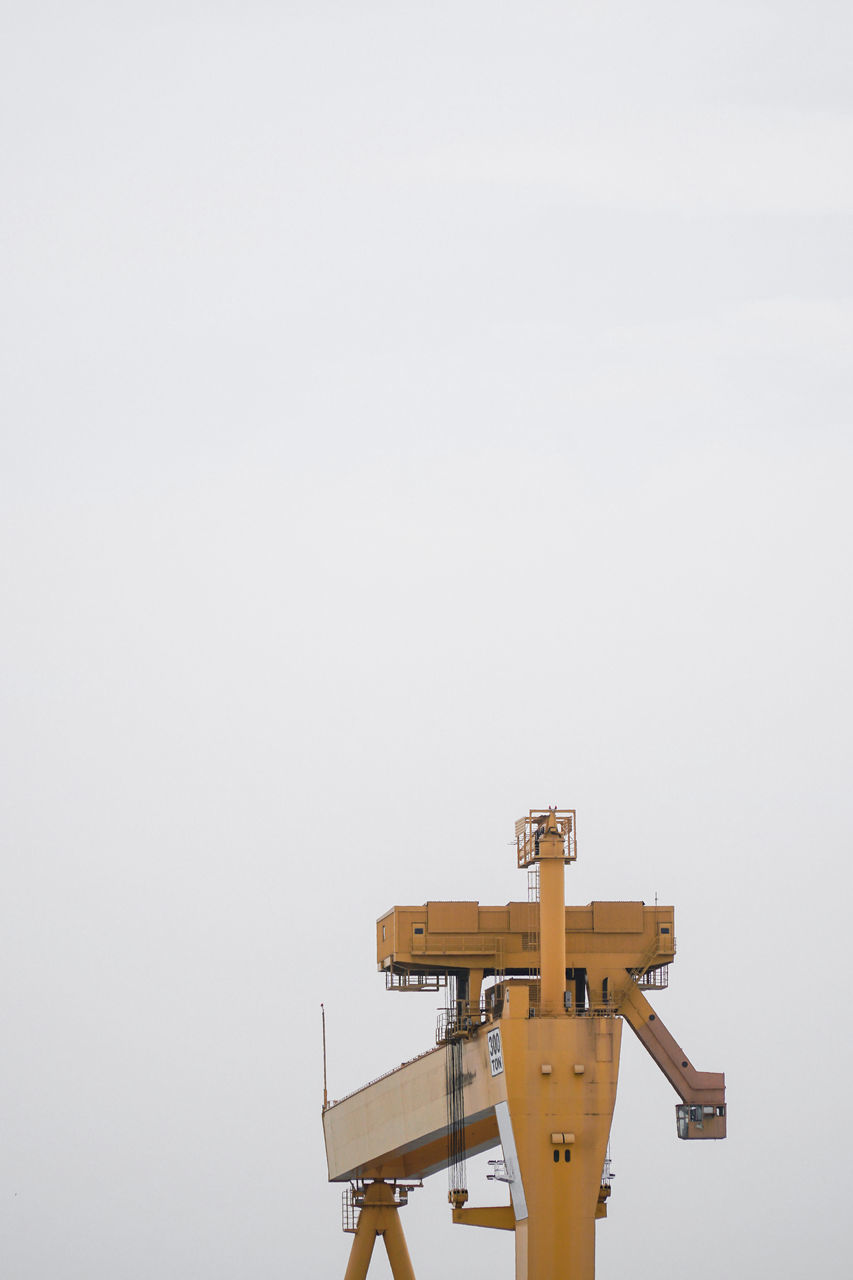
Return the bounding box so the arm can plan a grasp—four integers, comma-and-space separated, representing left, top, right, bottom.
0, 0, 853, 1280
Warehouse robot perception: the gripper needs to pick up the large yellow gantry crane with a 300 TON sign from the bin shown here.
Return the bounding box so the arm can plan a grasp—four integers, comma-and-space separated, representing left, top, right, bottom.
323, 809, 726, 1280
